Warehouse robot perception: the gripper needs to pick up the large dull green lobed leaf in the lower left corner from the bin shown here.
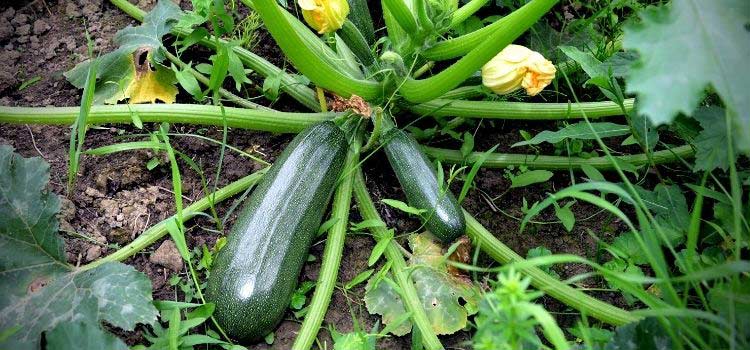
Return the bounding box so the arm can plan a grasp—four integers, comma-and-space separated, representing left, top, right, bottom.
0, 146, 157, 349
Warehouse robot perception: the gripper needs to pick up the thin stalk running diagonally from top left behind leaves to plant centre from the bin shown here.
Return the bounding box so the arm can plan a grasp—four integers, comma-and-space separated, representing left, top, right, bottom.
110, 0, 320, 111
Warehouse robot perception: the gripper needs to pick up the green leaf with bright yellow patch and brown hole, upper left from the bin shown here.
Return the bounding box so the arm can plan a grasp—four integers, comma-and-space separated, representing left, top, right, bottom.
65, 0, 182, 104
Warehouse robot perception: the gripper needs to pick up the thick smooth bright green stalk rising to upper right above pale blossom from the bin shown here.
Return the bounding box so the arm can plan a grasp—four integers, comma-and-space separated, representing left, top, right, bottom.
400, 0, 558, 103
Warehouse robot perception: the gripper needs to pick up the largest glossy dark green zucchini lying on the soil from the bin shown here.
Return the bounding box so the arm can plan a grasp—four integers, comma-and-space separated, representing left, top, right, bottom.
206, 122, 348, 341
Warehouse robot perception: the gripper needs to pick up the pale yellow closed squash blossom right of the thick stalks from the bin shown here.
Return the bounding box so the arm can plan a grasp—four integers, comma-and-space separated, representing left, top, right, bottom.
482, 45, 556, 96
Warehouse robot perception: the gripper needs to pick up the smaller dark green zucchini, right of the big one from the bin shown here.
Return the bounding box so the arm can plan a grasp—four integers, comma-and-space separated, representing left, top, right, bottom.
383, 128, 466, 243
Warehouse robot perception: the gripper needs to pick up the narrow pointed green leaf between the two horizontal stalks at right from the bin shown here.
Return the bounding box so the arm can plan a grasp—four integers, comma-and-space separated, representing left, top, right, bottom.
511, 122, 630, 147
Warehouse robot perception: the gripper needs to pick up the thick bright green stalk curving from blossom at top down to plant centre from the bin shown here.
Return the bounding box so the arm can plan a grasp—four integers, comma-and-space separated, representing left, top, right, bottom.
253, 0, 383, 100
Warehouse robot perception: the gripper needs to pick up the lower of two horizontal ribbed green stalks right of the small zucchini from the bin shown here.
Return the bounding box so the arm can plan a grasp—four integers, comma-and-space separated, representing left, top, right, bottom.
424, 145, 695, 170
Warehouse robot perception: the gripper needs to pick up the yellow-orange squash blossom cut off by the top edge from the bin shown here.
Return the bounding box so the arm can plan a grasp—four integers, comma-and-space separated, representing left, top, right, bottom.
299, 0, 349, 34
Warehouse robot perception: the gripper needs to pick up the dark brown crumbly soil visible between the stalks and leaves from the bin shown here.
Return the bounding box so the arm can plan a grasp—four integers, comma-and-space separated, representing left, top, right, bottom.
0, 0, 636, 349
